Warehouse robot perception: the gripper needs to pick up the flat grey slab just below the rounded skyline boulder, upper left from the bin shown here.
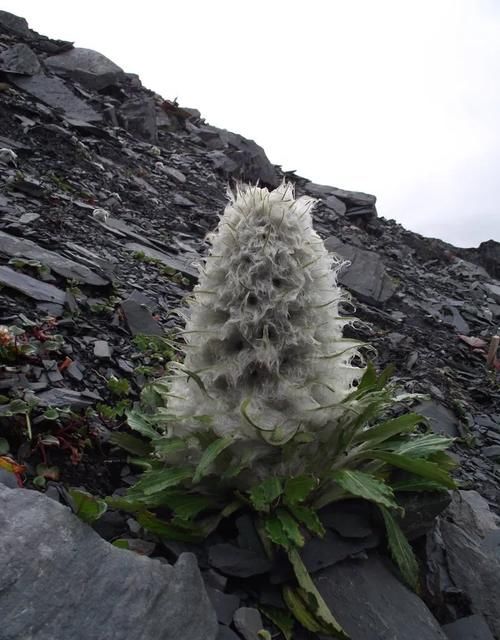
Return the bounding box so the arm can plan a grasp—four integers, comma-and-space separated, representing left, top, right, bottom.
9, 72, 102, 122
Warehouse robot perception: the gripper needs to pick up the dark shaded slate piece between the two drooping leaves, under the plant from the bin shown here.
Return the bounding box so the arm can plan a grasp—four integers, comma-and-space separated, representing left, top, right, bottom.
300, 530, 380, 574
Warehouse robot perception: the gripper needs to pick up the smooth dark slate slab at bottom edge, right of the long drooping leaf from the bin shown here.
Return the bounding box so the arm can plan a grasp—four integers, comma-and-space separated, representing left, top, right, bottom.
314, 553, 446, 640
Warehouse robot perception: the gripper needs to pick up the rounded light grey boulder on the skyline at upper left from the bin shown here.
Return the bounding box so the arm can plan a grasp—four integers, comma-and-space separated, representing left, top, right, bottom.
45, 47, 125, 91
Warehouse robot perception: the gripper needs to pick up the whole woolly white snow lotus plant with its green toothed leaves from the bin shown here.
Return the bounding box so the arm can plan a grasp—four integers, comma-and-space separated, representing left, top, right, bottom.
112, 183, 453, 637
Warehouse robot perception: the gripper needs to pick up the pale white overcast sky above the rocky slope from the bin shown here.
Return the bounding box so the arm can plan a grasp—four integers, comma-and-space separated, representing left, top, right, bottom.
1, 0, 500, 246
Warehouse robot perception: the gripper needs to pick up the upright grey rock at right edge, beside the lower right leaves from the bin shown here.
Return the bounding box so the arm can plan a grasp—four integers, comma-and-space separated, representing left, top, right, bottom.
427, 491, 500, 636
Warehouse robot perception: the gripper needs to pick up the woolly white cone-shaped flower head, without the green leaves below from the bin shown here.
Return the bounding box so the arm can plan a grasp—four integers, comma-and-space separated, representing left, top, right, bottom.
168, 183, 363, 456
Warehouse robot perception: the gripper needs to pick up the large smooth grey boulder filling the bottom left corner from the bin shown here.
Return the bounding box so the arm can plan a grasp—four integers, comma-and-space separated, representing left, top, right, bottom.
0, 485, 217, 640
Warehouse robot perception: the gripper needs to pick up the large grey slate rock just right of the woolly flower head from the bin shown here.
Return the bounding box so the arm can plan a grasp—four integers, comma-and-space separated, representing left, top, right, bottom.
325, 236, 396, 305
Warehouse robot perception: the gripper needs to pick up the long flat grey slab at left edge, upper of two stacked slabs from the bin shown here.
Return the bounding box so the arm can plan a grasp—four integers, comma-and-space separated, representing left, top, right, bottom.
0, 231, 109, 286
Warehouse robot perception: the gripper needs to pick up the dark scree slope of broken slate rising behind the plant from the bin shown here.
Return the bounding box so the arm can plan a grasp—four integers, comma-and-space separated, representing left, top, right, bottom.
0, 12, 500, 638
